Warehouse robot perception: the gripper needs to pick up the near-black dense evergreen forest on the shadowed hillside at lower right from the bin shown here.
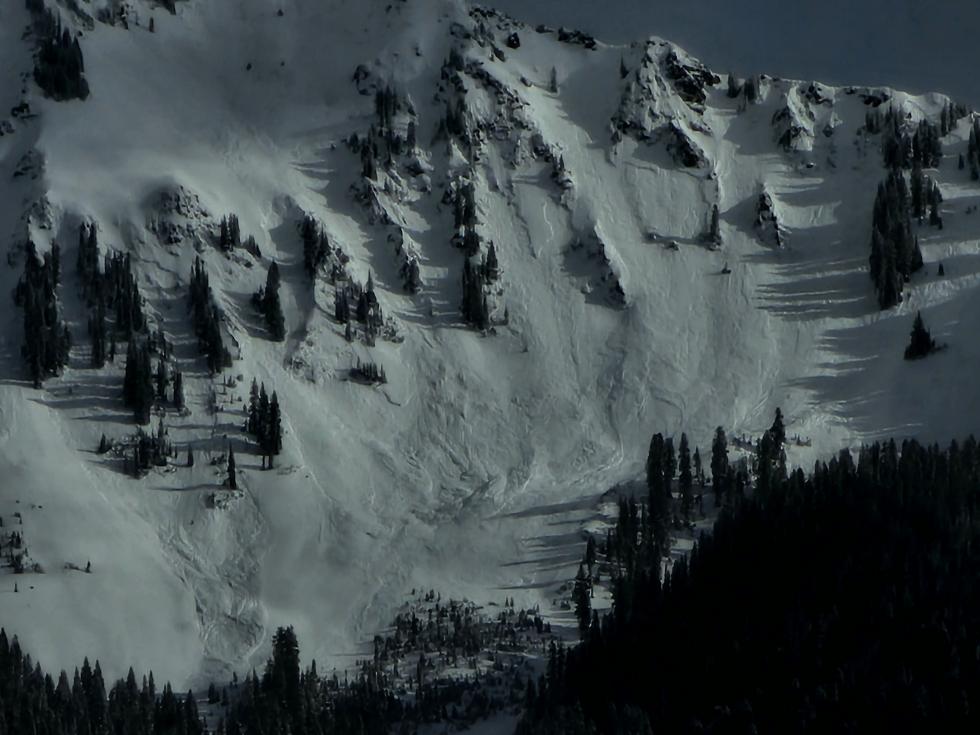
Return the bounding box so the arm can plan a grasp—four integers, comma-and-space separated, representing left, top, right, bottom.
518, 440, 980, 735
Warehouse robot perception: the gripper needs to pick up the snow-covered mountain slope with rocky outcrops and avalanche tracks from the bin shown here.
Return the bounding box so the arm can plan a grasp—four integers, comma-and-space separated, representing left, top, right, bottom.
0, 0, 980, 682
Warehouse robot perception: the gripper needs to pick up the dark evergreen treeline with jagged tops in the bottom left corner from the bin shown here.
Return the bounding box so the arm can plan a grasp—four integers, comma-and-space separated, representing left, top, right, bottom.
0, 628, 412, 735
